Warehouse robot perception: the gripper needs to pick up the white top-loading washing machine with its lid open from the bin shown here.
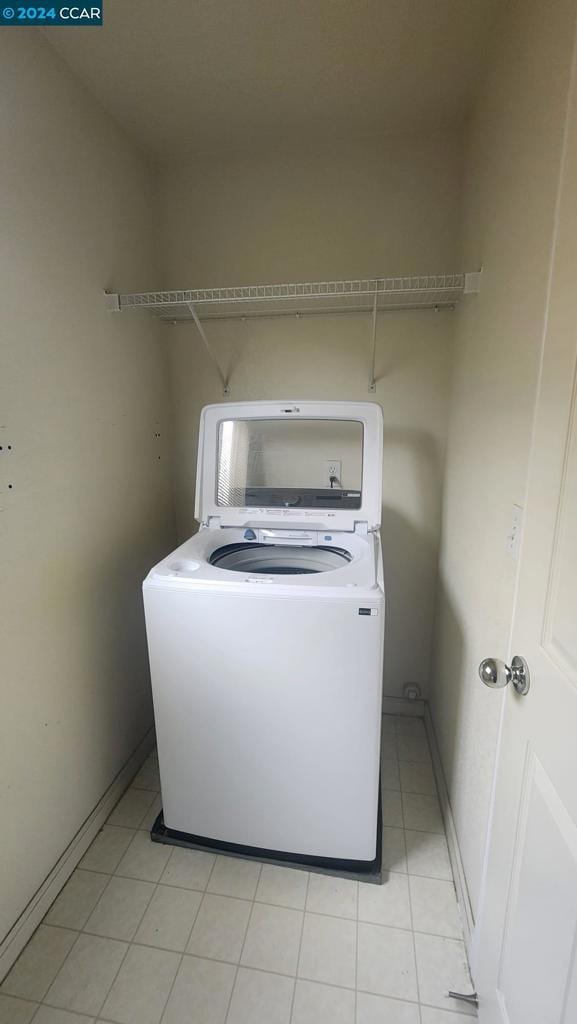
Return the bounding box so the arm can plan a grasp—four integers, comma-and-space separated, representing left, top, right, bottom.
143, 401, 384, 874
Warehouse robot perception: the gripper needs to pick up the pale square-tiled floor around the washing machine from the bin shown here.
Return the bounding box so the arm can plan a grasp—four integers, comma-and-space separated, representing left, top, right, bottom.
0, 717, 472, 1024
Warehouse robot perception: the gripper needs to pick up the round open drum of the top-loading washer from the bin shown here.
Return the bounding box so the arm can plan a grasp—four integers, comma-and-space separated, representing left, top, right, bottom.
210, 543, 352, 575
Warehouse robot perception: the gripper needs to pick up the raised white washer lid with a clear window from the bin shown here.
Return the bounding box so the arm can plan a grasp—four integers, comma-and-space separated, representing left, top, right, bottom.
195, 400, 382, 531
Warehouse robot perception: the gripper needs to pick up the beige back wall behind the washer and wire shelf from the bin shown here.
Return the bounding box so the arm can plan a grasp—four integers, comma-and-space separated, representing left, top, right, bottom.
157, 134, 460, 694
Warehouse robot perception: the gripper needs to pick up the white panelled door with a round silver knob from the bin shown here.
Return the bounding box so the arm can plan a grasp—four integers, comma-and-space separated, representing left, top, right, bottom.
475, 41, 577, 1024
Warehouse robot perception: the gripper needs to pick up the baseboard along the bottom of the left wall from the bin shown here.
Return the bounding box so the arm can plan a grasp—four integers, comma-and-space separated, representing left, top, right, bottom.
0, 729, 155, 981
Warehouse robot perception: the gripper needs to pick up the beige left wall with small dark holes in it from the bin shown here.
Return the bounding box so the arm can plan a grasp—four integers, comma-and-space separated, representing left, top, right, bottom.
0, 29, 173, 939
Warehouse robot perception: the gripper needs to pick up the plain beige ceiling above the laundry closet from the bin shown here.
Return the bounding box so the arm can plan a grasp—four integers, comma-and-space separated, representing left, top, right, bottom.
45, 0, 500, 162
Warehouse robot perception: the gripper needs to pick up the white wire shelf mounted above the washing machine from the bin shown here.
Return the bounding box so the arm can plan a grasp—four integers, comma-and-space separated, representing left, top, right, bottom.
107, 273, 469, 323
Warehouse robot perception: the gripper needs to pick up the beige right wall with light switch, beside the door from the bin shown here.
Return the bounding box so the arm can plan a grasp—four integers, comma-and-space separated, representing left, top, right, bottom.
432, 0, 575, 921
